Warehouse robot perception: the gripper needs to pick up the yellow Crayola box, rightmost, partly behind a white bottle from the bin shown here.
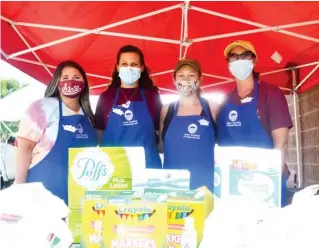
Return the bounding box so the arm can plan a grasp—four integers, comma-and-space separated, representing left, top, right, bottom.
144, 188, 206, 248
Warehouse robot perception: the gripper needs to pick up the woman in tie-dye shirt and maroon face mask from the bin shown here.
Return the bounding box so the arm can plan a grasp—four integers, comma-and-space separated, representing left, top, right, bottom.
15, 61, 97, 204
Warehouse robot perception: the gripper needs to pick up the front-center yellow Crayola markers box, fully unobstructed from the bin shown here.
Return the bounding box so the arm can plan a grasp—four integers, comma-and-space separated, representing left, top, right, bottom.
102, 195, 167, 248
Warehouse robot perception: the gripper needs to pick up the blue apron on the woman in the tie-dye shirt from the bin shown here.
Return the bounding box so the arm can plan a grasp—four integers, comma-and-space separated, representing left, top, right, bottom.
27, 100, 98, 205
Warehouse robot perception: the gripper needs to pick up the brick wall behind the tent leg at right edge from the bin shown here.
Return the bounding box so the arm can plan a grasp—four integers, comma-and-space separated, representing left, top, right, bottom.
287, 86, 319, 187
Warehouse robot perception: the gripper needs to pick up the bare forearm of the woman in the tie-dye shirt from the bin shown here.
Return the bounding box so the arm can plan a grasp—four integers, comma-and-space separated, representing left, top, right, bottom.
15, 151, 32, 184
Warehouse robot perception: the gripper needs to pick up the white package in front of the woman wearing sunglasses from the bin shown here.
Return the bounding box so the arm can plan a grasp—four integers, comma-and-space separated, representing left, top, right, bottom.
214, 146, 282, 207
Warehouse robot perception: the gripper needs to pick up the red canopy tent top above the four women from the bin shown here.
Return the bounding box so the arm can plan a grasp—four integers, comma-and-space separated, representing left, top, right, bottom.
1, 1, 319, 94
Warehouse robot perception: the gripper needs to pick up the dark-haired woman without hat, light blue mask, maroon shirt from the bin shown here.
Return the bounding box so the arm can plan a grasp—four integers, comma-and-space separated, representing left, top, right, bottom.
95, 45, 162, 168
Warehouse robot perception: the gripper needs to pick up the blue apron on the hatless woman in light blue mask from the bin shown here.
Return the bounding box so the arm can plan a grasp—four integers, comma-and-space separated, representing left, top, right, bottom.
100, 89, 162, 169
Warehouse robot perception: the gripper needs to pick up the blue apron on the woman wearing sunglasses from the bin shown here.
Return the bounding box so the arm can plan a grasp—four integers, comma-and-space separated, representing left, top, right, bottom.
217, 80, 287, 206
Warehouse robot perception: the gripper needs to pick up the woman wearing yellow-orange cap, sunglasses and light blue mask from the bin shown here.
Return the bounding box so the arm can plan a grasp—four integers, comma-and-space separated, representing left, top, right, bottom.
217, 40, 292, 206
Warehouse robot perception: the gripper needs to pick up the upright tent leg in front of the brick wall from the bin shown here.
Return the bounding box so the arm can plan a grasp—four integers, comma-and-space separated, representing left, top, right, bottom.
292, 70, 303, 188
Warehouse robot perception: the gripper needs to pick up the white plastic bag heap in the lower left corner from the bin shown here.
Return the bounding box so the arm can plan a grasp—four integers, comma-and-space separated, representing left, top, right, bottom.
0, 183, 73, 248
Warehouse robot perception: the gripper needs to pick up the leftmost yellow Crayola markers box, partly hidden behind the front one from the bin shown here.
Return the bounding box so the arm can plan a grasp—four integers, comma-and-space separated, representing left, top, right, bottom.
80, 190, 134, 248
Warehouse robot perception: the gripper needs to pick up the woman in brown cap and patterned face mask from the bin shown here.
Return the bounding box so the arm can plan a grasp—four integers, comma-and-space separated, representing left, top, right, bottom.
160, 59, 216, 191
